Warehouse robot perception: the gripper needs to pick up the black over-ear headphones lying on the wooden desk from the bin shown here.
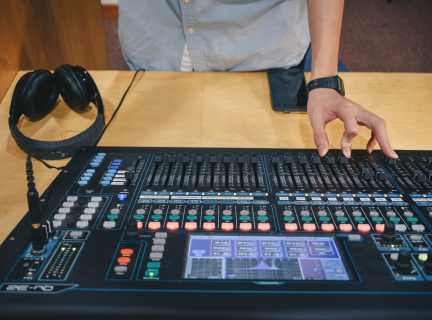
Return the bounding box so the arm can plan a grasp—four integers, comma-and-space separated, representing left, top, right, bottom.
9, 64, 105, 160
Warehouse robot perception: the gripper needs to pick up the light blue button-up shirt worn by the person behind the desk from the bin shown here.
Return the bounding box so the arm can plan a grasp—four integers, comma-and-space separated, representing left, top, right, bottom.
119, 0, 310, 71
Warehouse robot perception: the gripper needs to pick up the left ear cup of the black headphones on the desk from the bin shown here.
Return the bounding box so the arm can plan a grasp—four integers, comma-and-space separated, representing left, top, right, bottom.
17, 70, 59, 121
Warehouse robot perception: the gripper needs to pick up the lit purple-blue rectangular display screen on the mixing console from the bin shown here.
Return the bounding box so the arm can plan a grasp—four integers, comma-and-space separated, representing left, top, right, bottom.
184, 235, 350, 281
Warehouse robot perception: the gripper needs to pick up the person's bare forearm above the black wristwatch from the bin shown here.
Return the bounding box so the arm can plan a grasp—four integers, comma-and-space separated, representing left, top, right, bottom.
307, 0, 344, 80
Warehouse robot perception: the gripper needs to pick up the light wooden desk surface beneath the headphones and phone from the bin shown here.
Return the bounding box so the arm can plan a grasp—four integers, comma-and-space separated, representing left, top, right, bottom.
0, 71, 432, 243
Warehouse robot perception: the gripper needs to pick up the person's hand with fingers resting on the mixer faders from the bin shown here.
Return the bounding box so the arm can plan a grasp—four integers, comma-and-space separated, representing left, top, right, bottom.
307, 88, 398, 158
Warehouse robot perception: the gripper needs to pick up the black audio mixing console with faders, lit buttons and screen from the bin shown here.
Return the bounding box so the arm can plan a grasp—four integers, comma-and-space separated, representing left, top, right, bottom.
0, 147, 432, 319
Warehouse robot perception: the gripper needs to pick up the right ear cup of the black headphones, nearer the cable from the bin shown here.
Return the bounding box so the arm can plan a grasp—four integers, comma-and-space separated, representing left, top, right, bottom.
54, 64, 90, 111
